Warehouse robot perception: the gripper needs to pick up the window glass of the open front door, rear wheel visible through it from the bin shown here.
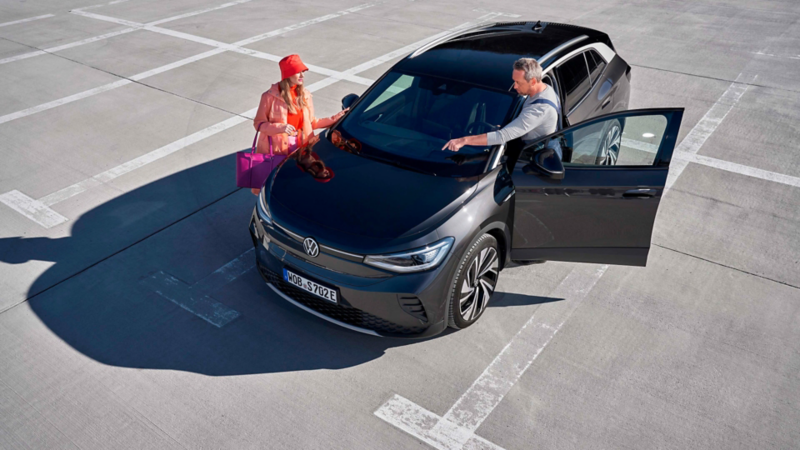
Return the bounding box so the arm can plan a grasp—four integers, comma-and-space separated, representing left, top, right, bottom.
520, 114, 668, 168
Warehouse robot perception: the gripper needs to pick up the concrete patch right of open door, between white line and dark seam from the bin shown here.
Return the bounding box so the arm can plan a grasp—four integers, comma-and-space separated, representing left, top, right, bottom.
653, 164, 800, 286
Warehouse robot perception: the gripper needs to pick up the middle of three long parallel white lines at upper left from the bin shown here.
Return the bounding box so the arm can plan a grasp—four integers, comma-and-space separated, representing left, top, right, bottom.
0, 4, 373, 124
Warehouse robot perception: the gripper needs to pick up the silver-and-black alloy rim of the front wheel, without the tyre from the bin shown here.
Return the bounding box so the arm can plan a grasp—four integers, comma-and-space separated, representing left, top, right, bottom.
459, 247, 500, 321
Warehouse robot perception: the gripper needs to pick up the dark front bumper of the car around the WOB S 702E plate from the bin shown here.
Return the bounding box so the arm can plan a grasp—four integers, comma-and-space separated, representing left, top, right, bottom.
249, 210, 451, 338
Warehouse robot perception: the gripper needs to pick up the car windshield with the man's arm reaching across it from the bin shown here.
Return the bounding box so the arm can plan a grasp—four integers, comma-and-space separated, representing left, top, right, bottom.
337, 72, 516, 177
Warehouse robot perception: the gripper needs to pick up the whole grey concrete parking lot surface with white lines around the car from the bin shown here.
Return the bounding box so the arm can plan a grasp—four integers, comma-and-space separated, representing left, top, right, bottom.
0, 0, 800, 450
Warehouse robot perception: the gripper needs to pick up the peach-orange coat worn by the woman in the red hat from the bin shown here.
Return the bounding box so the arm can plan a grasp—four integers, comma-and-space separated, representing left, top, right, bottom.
253, 83, 334, 155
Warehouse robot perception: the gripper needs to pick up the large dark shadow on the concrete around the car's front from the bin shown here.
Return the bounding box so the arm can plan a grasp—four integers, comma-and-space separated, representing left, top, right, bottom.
0, 156, 556, 376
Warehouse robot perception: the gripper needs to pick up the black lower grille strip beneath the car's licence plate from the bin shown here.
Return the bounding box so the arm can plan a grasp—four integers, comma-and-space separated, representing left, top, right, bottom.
258, 264, 426, 334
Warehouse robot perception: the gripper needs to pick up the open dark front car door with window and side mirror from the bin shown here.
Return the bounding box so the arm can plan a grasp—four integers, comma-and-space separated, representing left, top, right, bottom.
507, 108, 683, 266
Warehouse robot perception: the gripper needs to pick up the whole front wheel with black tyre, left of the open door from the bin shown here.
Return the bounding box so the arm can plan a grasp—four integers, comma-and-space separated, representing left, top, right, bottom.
447, 234, 500, 330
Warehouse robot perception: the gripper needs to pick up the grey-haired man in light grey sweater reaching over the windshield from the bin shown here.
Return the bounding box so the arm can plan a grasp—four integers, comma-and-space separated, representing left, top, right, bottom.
442, 58, 561, 158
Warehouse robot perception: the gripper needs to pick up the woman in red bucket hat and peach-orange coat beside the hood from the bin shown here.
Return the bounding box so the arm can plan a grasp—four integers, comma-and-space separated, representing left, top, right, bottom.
252, 55, 347, 195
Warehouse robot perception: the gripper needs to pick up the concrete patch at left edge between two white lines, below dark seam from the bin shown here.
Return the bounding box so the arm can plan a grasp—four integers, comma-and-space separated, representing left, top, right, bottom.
0, 55, 119, 116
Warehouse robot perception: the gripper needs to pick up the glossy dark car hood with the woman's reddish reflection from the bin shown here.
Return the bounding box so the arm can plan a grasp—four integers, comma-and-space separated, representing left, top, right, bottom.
269, 139, 477, 241
